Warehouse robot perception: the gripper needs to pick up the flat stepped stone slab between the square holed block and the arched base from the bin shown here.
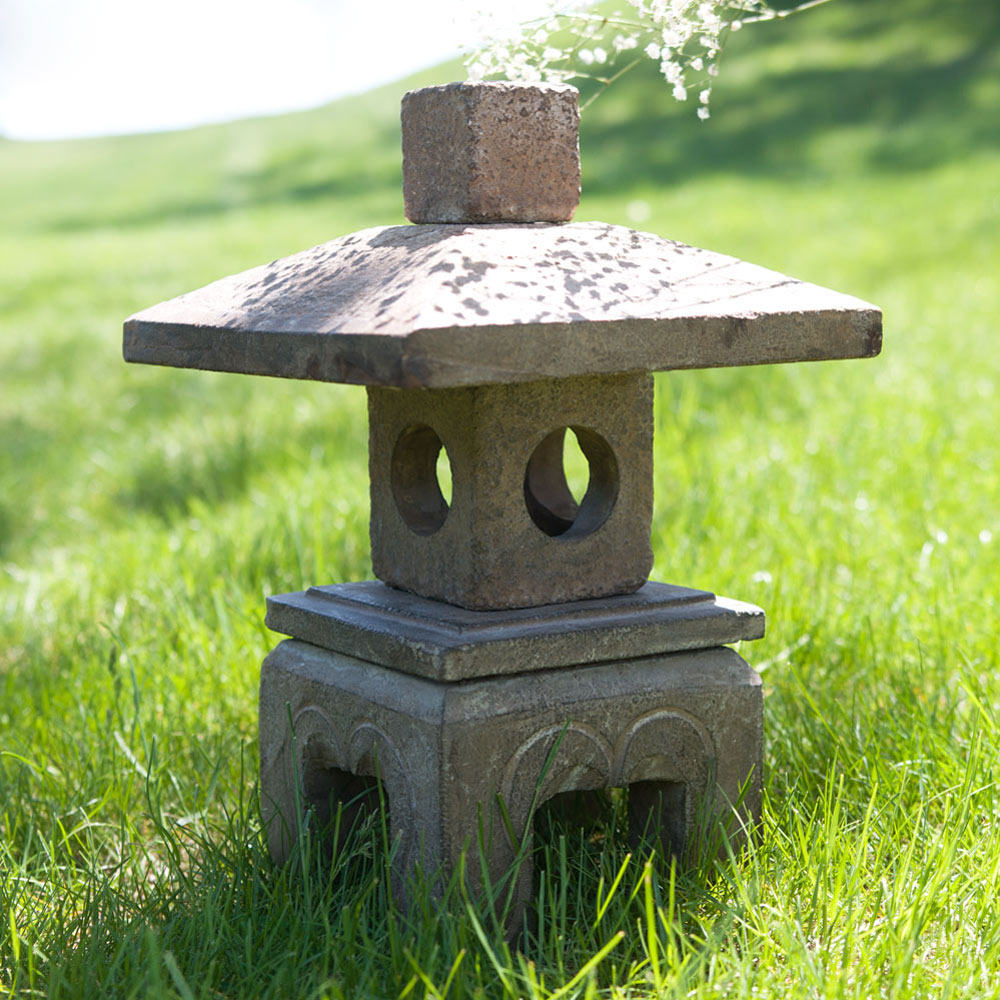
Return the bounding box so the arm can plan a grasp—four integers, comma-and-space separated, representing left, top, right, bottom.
267, 580, 764, 681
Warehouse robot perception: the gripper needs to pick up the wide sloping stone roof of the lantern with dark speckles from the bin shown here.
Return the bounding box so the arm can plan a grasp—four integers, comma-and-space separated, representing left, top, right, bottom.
124, 222, 882, 388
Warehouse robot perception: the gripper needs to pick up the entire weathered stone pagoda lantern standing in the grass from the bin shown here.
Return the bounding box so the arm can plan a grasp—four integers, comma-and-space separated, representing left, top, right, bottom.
124, 83, 881, 916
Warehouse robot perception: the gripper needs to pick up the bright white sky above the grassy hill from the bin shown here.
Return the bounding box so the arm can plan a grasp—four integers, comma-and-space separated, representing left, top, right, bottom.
0, 0, 544, 139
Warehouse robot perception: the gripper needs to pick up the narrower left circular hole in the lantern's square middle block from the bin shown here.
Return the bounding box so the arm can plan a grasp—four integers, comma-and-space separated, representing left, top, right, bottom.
389, 424, 451, 535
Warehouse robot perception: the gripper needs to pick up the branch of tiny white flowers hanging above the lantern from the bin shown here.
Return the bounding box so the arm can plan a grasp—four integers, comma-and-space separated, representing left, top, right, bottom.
465, 0, 829, 119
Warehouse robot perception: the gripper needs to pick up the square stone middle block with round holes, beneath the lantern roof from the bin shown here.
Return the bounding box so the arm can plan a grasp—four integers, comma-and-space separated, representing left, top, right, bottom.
368, 375, 653, 610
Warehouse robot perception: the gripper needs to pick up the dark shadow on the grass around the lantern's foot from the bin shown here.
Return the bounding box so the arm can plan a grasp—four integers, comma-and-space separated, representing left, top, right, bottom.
25, 752, 752, 998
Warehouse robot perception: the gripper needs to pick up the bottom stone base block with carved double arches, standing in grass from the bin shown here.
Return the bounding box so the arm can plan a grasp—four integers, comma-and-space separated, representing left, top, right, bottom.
260, 640, 762, 923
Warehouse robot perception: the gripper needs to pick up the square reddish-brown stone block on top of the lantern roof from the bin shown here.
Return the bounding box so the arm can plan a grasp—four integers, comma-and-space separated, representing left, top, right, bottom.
402, 82, 580, 223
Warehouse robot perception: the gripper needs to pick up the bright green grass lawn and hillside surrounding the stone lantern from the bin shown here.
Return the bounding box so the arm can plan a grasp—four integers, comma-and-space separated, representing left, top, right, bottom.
0, 0, 1000, 998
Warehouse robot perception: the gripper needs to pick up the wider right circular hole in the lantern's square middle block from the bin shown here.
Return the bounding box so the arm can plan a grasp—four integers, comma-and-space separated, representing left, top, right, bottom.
524, 426, 618, 539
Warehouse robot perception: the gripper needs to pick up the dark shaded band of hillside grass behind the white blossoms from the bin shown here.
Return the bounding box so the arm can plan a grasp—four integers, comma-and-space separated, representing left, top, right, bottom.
581, 0, 1000, 194
